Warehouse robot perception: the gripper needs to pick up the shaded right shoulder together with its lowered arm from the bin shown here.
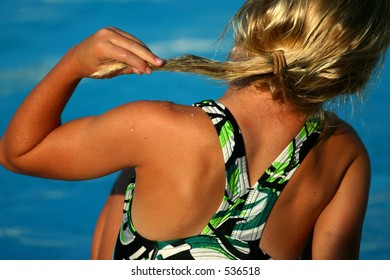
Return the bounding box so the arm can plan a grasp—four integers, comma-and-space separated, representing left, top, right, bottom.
313, 111, 371, 259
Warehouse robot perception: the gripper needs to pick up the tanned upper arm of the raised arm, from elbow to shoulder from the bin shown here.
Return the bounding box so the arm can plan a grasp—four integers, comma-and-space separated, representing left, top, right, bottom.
3, 102, 175, 180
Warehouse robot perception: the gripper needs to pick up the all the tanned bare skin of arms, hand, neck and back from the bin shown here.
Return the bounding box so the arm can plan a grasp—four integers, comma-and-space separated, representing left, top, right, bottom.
0, 28, 370, 259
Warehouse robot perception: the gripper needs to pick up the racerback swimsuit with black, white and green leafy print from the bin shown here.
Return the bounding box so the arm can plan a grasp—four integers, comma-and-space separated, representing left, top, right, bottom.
113, 100, 322, 260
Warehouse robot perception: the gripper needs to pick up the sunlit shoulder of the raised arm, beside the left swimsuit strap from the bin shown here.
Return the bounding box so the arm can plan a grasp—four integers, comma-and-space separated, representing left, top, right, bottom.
114, 101, 216, 150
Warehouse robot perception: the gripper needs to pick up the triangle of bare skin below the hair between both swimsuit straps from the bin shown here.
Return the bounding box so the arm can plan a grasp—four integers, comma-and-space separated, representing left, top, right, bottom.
216, 86, 306, 185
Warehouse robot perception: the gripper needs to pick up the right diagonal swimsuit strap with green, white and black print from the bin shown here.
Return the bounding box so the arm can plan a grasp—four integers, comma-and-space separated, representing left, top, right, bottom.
232, 119, 323, 240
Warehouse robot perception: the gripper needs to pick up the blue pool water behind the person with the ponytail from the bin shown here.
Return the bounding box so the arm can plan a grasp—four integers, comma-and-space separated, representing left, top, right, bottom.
0, 0, 390, 259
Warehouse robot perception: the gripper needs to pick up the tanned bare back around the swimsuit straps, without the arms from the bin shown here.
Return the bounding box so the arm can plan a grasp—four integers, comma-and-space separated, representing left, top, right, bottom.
110, 86, 367, 258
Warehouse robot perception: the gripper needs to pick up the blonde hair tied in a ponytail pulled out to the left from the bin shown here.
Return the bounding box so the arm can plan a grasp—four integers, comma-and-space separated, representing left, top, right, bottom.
94, 0, 390, 112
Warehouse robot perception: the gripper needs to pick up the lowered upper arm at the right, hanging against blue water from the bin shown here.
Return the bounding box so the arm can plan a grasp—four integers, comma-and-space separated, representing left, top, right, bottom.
312, 132, 370, 259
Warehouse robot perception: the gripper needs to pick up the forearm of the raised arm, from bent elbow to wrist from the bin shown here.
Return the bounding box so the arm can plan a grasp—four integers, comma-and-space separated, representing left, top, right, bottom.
0, 51, 80, 164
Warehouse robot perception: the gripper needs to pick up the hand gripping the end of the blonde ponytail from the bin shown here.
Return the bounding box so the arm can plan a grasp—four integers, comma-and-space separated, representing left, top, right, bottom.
69, 27, 163, 78
